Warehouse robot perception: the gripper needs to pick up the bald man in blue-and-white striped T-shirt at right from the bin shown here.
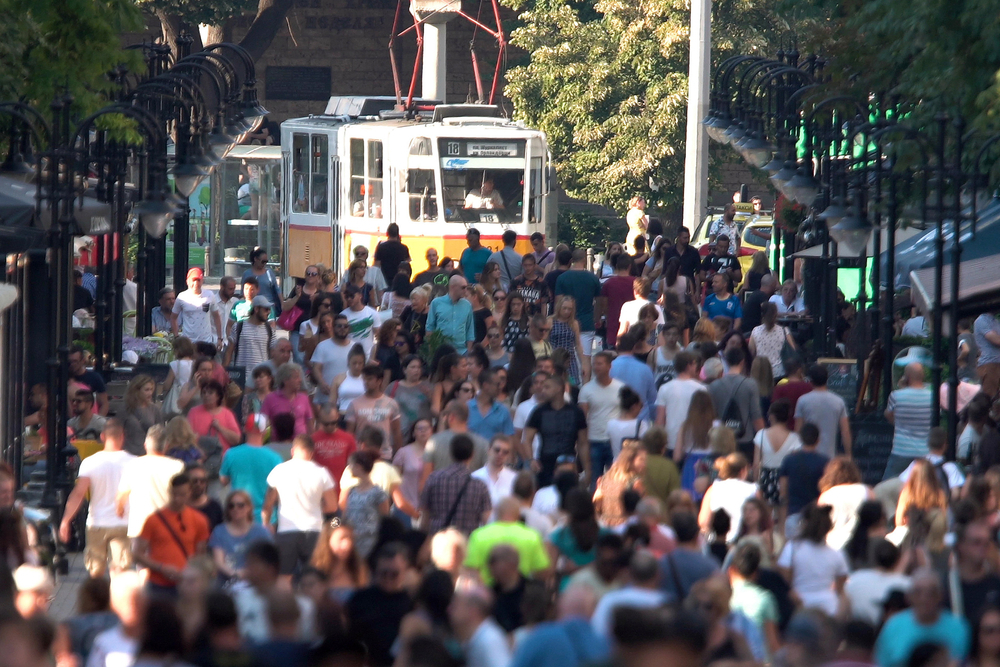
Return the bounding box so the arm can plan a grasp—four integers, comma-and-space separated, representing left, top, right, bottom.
882, 361, 934, 480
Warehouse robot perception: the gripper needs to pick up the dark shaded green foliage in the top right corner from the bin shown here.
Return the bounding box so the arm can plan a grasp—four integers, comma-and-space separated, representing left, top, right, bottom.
783, 0, 1000, 130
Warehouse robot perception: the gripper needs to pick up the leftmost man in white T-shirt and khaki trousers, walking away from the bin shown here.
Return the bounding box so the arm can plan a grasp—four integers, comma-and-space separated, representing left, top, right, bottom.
59, 417, 135, 577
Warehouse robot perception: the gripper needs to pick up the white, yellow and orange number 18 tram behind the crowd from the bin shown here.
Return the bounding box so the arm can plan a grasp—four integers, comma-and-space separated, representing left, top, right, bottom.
281, 97, 557, 284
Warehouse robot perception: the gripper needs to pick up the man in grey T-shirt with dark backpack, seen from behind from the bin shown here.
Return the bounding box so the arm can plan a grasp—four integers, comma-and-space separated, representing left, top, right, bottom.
708, 347, 764, 461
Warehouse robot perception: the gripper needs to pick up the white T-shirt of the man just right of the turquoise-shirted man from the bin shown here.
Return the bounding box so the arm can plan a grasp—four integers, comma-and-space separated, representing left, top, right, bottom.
267, 459, 335, 533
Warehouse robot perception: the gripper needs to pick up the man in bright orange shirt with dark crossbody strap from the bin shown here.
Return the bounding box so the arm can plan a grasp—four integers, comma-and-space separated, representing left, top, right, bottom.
132, 473, 209, 595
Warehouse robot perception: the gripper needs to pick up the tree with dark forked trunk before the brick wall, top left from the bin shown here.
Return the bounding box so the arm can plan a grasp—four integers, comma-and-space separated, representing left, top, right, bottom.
137, 0, 295, 60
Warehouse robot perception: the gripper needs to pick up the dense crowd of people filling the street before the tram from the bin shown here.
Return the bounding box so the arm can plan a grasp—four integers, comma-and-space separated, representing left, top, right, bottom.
0, 215, 1000, 667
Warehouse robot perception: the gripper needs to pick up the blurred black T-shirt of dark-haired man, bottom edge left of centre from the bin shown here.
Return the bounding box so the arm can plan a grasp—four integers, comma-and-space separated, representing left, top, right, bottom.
346, 586, 413, 667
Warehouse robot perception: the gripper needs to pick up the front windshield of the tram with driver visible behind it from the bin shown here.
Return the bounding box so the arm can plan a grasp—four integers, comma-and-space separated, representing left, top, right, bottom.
439, 139, 526, 224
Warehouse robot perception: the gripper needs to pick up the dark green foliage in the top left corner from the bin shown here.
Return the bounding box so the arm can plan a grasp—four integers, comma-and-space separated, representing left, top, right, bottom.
0, 0, 143, 117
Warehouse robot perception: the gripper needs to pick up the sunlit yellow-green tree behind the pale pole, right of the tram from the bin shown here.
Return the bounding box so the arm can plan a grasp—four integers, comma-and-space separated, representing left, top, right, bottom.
505, 0, 778, 210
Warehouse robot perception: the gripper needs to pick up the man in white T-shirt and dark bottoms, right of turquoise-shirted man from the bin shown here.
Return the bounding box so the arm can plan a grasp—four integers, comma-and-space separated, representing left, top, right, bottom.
261, 435, 337, 583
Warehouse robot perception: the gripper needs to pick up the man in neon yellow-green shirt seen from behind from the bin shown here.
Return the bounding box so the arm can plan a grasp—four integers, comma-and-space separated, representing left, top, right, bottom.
465, 497, 550, 586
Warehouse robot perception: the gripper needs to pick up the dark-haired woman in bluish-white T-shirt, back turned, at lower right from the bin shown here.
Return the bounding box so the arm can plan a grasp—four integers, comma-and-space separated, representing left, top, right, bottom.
778, 503, 848, 618
